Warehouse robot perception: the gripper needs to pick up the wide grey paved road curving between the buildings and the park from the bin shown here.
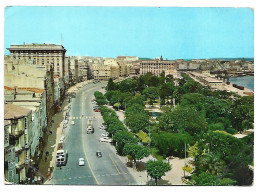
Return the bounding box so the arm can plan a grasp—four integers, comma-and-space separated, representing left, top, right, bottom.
51, 83, 137, 185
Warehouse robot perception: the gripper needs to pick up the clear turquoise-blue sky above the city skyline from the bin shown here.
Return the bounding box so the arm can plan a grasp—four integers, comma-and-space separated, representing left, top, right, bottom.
5, 7, 254, 59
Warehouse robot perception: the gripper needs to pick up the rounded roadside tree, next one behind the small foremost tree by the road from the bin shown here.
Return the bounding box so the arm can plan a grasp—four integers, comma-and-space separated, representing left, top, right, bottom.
123, 143, 149, 165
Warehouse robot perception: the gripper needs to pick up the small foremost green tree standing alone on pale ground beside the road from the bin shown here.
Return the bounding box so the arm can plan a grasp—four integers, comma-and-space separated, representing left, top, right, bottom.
146, 160, 171, 185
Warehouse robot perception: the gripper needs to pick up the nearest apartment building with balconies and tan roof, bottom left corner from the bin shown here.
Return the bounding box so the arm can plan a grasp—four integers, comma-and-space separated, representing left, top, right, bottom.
4, 104, 32, 184
